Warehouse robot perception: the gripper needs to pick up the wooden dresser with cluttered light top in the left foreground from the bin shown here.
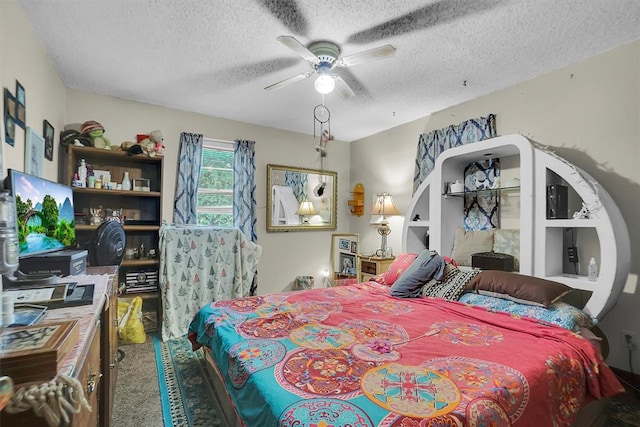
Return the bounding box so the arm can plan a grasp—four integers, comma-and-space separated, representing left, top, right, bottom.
0, 266, 118, 427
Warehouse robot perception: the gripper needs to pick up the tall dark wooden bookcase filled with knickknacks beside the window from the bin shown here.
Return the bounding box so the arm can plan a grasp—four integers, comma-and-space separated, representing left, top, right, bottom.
58, 145, 163, 331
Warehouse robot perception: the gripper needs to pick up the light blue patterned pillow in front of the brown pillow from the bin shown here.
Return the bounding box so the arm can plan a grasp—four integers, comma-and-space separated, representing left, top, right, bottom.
459, 293, 597, 332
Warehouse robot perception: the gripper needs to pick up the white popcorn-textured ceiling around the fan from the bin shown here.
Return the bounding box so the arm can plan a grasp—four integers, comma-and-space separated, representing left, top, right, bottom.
18, 0, 640, 141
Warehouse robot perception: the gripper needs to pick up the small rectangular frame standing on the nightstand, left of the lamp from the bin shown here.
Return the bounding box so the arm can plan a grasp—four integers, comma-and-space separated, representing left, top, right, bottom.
331, 233, 360, 286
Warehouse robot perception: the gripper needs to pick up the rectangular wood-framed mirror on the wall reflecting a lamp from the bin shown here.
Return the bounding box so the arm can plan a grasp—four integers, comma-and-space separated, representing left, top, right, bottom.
267, 165, 338, 231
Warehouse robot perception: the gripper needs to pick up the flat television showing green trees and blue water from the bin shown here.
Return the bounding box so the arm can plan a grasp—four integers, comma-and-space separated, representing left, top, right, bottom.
4, 169, 76, 258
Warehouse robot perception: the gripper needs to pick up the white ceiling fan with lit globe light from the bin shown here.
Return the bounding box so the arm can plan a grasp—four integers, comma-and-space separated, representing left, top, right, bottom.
265, 36, 396, 99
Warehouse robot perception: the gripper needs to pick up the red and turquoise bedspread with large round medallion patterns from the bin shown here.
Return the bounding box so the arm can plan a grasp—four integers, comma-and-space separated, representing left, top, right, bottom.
189, 282, 622, 427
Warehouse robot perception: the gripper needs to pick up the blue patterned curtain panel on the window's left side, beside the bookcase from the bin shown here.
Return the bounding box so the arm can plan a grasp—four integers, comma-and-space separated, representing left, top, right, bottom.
173, 132, 203, 224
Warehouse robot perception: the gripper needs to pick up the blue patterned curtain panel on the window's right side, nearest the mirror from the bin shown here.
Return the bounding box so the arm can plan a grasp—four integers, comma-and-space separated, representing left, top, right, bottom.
233, 140, 258, 242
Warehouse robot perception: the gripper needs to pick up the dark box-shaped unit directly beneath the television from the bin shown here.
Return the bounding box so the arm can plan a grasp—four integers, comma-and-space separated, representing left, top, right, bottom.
19, 249, 89, 276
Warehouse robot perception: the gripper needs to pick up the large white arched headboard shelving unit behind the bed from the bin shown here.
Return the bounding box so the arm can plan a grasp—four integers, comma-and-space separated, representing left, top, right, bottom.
402, 135, 631, 319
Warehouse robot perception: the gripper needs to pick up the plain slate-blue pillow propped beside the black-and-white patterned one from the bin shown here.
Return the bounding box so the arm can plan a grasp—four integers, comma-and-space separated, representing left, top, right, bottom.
389, 249, 445, 298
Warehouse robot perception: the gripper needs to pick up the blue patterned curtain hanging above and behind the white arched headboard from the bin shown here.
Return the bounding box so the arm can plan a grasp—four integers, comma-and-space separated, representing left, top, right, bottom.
413, 114, 496, 193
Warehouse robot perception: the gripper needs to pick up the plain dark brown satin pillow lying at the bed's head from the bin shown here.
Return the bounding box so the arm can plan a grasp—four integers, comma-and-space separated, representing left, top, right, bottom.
467, 270, 573, 307
